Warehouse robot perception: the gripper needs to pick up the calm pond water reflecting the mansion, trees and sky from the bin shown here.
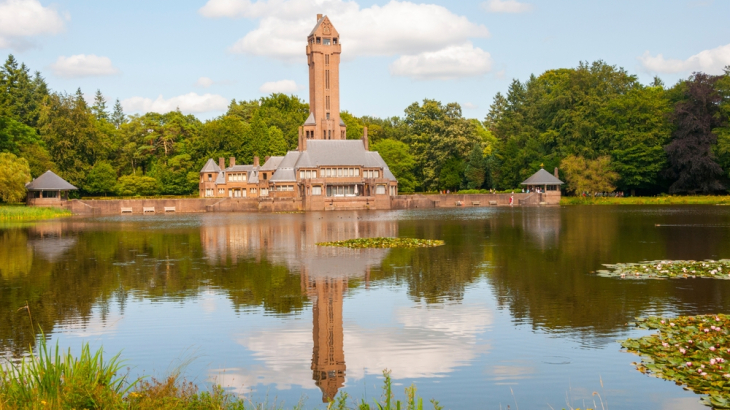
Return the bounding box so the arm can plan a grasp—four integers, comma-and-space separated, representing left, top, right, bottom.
0, 206, 730, 409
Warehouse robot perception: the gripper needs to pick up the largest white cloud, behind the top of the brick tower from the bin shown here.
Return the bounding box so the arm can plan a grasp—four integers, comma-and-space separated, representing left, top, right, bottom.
199, 0, 489, 65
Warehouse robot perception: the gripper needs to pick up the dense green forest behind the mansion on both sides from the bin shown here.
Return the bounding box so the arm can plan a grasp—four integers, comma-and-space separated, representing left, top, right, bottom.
0, 55, 730, 202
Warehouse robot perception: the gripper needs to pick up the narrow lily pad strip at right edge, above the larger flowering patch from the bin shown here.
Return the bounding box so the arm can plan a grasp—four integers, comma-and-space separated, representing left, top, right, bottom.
596, 259, 730, 280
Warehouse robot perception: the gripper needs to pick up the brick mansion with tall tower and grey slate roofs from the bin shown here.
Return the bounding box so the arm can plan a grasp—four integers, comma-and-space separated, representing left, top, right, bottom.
199, 14, 398, 210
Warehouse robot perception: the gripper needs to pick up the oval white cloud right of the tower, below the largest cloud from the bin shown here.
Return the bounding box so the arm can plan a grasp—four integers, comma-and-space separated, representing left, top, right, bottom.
390, 42, 492, 80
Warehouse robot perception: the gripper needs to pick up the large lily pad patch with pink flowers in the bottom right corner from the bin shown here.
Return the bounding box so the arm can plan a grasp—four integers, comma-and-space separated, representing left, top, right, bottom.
621, 315, 730, 409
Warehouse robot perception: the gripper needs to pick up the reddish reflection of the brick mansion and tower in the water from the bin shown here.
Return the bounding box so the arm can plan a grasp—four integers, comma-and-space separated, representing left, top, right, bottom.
201, 213, 398, 402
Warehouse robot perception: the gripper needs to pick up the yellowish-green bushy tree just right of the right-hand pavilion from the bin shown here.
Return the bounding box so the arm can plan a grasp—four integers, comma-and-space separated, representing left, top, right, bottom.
560, 155, 619, 197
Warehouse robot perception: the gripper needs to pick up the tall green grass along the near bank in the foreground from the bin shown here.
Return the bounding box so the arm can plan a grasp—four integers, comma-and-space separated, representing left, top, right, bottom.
0, 335, 443, 410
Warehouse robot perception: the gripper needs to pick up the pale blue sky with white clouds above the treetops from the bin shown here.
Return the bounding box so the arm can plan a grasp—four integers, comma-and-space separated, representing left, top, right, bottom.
0, 0, 730, 119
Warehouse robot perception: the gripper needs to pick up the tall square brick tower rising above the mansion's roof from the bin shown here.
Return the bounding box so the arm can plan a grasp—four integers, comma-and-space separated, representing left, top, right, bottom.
300, 14, 346, 145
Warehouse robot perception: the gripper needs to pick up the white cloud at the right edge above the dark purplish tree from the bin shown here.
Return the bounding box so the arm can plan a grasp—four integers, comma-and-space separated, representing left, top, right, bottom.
639, 44, 730, 74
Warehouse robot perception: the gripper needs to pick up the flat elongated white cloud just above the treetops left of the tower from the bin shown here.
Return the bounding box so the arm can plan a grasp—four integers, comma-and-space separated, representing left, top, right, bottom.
122, 93, 228, 114
